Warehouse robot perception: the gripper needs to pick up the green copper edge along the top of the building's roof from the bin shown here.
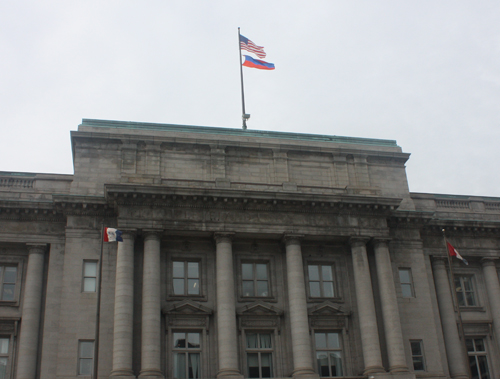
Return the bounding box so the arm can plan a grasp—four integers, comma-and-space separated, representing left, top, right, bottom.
81, 118, 398, 147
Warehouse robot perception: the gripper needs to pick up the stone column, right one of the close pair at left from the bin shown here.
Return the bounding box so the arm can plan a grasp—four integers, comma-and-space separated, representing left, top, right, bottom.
139, 231, 163, 378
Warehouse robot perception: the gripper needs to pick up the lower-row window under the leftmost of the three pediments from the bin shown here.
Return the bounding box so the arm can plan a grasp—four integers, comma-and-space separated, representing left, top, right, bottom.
172, 332, 201, 379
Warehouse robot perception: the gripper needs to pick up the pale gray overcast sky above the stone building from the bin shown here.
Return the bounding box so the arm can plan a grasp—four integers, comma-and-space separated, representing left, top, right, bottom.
0, 0, 500, 197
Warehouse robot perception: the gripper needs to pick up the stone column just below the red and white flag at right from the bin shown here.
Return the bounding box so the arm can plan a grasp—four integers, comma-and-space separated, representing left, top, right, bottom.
432, 258, 469, 379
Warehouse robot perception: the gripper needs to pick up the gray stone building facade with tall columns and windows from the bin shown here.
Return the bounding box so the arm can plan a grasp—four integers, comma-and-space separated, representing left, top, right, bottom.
0, 119, 500, 379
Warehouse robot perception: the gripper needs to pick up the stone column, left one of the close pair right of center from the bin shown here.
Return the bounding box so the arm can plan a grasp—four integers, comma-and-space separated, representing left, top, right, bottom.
350, 238, 385, 375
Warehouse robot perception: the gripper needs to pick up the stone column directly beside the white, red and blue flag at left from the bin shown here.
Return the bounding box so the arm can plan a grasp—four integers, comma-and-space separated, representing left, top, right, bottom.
111, 231, 135, 378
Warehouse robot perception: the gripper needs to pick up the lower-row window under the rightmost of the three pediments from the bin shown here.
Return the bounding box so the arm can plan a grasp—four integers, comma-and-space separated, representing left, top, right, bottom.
314, 332, 344, 378
